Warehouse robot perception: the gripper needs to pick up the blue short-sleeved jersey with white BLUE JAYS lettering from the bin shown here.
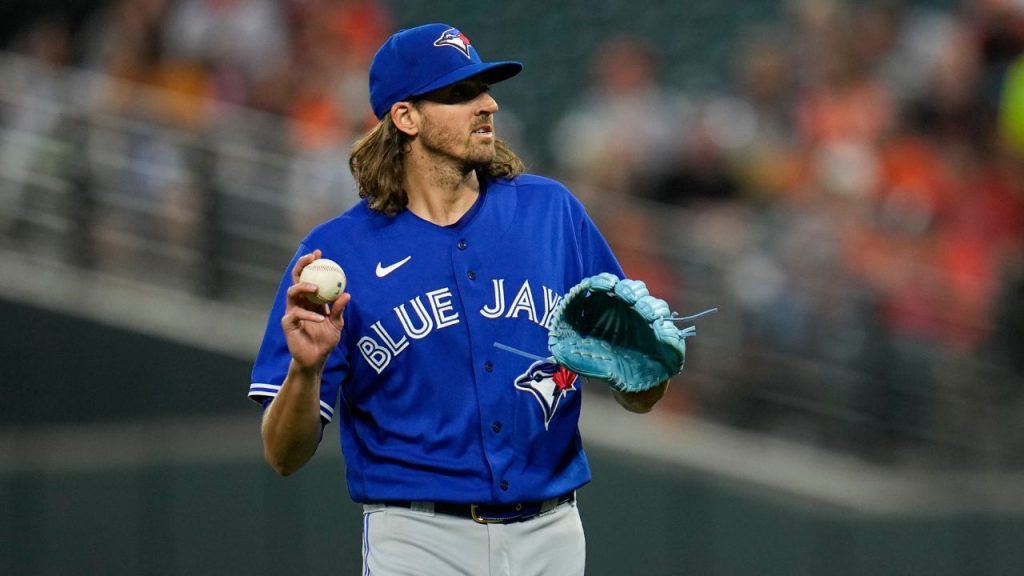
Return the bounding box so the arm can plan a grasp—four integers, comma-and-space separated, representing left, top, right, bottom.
249, 175, 623, 503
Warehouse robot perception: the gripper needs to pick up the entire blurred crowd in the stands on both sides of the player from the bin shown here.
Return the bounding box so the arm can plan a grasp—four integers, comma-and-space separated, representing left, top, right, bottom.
0, 0, 1024, 465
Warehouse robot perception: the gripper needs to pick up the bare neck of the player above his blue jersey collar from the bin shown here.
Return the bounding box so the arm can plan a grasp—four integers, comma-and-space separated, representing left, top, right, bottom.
406, 161, 480, 227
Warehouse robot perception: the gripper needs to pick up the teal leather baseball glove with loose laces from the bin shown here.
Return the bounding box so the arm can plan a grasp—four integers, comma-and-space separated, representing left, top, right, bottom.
548, 274, 717, 392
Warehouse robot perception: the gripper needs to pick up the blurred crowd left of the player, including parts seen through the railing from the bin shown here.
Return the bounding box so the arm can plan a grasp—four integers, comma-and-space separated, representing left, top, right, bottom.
6, 0, 394, 239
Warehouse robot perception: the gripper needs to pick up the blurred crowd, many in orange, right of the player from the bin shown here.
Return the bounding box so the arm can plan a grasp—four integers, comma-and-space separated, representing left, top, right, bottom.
552, 0, 1024, 463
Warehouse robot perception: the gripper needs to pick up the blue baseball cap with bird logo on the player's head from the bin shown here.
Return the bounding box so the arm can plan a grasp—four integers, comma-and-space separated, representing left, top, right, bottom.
370, 24, 522, 119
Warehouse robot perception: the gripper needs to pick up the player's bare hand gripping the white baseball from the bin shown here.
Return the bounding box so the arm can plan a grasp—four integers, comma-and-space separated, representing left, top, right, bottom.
281, 249, 351, 369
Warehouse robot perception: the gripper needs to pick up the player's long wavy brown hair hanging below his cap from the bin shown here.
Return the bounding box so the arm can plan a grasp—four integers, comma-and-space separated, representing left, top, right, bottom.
348, 115, 525, 216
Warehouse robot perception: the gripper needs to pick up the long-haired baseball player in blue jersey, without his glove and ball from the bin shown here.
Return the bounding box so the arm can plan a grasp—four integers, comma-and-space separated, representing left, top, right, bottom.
249, 24, 667, 576
